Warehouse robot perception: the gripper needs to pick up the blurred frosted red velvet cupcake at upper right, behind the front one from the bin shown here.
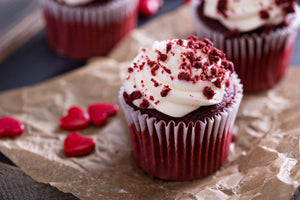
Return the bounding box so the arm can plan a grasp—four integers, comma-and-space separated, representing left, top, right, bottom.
192, 0, 300, 91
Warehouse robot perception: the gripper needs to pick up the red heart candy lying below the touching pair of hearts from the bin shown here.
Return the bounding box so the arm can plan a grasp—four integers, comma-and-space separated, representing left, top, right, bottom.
64, 132, 95, 157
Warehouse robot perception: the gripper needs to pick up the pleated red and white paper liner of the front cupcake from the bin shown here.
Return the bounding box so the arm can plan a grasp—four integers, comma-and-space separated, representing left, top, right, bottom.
119, 74, 243, 181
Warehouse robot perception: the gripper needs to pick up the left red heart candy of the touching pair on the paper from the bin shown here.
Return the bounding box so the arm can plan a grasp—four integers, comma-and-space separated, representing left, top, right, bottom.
59, 106, 90, 131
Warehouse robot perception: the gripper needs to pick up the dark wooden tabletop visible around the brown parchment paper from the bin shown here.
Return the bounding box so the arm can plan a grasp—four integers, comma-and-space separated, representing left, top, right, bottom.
0, 0, 300, 200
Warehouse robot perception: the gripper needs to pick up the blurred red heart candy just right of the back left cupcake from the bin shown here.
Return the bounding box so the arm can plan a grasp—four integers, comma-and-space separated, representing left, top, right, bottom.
139, 0, 163, 17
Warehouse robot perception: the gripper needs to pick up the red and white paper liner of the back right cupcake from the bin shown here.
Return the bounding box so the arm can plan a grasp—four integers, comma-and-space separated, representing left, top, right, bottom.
192, 1, 300, 92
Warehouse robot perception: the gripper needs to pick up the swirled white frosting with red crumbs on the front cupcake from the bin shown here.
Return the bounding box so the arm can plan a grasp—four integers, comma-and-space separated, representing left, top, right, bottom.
124, 36, 233, 117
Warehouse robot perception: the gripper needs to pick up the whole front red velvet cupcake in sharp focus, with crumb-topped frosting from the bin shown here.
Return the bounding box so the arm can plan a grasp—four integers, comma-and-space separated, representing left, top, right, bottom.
119, 36, 242, 181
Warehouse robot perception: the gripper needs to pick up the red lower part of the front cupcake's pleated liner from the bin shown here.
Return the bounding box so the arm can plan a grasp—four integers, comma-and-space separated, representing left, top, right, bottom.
129, 124, 231, 181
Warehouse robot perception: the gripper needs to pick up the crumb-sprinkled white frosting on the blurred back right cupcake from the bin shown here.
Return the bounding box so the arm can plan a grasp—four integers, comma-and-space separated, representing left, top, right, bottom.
204, 0, 296, 32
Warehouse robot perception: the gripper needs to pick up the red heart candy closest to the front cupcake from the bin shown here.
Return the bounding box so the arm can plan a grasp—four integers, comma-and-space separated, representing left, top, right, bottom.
88, 103, 119, 126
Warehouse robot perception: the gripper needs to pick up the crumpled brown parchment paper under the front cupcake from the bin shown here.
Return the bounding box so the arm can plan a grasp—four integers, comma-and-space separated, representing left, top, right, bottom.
0, 4, 300, 200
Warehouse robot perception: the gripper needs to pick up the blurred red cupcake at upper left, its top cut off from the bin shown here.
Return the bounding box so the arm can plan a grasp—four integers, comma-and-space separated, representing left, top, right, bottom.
41, 0, 138, 60
